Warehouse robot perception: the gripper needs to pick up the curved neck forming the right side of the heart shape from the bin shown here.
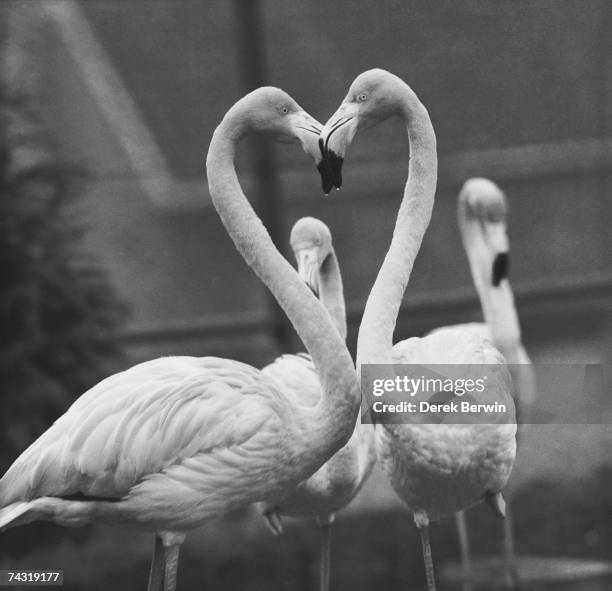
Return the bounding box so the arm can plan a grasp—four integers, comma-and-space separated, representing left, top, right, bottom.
357, 86, 438, 367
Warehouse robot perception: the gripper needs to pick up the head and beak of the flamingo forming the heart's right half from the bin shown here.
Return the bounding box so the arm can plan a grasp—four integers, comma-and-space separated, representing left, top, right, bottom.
319, 69, 407, 190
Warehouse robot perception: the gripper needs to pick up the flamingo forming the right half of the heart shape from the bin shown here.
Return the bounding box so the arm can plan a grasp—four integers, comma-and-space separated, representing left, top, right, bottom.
319, 69, 516, 591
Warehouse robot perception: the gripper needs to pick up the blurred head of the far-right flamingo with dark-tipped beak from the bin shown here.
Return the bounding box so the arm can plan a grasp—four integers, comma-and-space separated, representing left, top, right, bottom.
458, 178, 510, 287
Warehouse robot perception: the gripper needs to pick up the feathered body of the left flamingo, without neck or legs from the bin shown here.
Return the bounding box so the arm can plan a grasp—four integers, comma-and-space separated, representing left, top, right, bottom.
0, 357, 330, 531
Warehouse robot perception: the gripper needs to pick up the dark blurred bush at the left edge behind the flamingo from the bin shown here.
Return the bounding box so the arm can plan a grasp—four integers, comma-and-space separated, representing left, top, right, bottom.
0, 95, 125, 472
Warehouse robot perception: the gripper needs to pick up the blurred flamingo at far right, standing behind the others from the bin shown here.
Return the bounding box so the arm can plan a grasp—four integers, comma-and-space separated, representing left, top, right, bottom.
444, 178, 536, 591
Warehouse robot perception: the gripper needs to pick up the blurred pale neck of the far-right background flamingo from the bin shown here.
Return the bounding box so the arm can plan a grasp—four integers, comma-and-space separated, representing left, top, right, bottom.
460, 220, 522, 364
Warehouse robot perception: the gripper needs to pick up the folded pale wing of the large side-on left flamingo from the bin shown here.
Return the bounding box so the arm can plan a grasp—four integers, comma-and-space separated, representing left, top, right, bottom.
0, 357, 280, 506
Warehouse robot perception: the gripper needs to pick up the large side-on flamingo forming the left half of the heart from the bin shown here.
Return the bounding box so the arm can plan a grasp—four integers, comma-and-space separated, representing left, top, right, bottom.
0, 87, 359, 591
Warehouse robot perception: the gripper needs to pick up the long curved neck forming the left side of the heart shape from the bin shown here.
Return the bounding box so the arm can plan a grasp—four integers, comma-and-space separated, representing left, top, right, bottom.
206, 113, 359, 463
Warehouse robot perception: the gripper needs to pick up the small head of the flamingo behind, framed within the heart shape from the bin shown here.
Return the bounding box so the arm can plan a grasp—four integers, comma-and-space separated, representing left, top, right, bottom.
290, 217, 332, 296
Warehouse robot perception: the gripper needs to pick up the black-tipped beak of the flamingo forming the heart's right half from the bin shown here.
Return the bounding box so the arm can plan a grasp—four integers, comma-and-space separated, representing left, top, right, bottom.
319, 103, 359, 189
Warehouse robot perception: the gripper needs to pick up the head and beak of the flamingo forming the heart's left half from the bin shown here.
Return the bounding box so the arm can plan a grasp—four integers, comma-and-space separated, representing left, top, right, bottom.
233, 86, 330, 191
